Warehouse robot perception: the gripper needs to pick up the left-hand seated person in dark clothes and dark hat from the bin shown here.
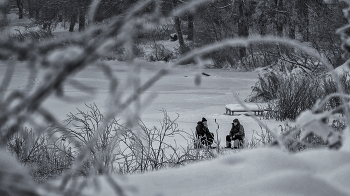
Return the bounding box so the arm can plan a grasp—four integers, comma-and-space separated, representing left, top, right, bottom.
196, 118, 214, 147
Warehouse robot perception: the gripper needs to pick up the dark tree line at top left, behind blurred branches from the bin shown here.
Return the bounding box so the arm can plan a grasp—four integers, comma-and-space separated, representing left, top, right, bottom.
8, 0, 137, 32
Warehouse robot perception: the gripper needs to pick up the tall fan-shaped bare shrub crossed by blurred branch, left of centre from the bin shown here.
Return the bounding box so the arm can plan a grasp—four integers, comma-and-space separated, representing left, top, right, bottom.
56, 104, 119, 176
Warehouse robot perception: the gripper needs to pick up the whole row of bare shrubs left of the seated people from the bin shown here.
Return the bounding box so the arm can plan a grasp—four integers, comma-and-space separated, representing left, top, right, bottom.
6, 104, 224, 183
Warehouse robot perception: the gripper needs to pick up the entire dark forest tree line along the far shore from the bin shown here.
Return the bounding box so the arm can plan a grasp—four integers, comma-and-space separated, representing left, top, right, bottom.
9, 0, 347, 69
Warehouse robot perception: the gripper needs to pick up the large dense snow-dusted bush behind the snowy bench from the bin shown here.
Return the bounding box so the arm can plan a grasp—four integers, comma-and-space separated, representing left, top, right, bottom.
250, 70, 350, 121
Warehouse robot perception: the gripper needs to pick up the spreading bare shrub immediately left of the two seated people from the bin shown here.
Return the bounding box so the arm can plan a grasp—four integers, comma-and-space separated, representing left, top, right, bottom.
117, 110, 196, 173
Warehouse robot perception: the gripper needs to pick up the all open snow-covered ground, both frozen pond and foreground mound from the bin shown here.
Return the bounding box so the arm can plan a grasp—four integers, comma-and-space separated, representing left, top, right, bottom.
0, 61, 350, 196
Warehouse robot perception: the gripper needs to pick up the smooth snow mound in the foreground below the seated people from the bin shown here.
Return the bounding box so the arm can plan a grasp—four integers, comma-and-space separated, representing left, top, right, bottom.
79, 148, 350, 196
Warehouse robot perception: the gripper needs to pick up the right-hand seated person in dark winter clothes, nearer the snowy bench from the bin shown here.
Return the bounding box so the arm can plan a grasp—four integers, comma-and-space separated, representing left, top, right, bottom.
226, 119, 245, 148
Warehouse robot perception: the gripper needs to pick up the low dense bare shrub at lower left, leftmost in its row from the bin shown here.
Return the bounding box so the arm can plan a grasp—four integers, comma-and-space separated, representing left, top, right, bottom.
7, 128, 74, 183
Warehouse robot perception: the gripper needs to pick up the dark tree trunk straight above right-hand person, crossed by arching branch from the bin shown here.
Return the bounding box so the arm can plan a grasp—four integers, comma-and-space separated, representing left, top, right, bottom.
237, 0, 249, 59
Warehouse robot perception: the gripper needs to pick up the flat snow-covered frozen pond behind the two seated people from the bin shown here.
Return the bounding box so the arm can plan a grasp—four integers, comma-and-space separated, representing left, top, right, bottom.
0, 61, 284, 146
